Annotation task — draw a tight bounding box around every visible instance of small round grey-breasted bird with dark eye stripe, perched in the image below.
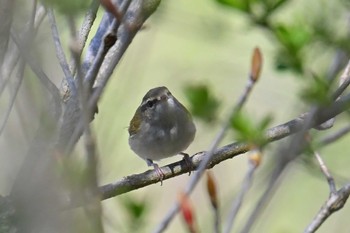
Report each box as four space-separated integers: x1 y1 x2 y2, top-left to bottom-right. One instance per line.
129 87 196 182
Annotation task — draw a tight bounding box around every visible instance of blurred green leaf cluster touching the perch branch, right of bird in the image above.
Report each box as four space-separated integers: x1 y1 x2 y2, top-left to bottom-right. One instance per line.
231 112 272 147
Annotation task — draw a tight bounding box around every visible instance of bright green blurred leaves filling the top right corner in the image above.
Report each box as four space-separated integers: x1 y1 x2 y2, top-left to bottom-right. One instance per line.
216 0 350 74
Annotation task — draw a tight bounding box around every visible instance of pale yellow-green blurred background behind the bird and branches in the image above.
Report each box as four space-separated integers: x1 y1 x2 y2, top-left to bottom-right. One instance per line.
0 0 350 233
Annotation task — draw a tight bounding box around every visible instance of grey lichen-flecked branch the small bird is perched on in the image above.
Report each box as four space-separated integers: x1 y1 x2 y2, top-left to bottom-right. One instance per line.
78 92 350 206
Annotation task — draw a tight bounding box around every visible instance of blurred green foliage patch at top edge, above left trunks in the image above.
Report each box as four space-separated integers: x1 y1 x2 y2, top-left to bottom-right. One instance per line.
41 0 91 16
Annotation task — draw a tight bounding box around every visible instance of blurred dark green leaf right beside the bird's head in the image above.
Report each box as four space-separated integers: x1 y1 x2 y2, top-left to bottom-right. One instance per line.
185 85 220 123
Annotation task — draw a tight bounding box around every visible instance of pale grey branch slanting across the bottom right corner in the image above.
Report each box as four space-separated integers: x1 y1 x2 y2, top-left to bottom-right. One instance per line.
304 183 350 233
